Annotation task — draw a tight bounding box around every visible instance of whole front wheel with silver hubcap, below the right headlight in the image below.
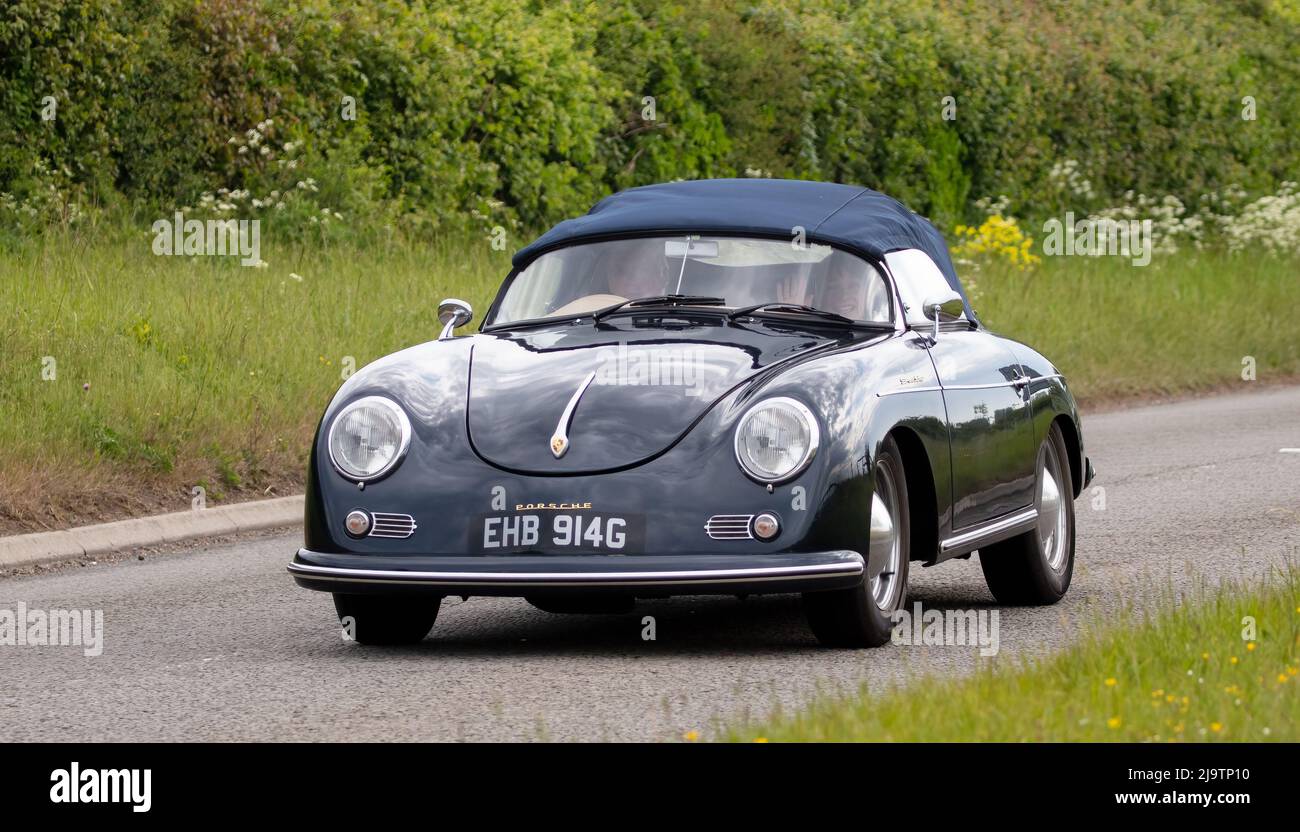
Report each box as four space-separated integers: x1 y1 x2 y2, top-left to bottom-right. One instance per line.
803 437 911 647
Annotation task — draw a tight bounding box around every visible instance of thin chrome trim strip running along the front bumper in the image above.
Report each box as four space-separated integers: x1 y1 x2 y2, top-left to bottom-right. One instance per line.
289 556 866 586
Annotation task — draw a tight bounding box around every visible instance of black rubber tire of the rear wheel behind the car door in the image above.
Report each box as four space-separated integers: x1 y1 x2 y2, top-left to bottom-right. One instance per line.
979 423 1074 606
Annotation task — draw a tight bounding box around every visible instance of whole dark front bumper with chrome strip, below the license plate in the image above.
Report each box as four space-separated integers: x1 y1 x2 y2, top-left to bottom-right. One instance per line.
289 549 866 597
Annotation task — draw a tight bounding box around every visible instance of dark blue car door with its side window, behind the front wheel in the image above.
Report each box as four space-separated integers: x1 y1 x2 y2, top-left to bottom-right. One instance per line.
885 250 1037 532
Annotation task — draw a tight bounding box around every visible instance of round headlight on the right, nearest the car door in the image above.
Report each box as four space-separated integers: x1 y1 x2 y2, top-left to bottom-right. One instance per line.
736 398 818 484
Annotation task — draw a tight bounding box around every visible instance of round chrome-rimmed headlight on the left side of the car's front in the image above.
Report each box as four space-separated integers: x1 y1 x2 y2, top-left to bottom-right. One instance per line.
329 395 411 482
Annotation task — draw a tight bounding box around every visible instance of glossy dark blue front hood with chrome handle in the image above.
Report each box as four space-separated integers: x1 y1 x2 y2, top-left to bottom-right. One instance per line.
467 316 850 475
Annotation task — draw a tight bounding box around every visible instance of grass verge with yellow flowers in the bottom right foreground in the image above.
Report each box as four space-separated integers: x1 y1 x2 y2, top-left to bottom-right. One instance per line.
723 566 1300 742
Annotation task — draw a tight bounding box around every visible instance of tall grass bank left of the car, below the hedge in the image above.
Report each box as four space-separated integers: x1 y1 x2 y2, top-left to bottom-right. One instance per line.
0 222 508 528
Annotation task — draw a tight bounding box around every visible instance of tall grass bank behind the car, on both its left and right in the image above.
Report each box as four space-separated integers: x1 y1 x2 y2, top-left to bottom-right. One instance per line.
0 224 1300 532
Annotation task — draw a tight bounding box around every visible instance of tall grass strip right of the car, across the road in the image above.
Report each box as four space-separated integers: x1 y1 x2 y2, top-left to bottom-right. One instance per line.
974 251 1300 402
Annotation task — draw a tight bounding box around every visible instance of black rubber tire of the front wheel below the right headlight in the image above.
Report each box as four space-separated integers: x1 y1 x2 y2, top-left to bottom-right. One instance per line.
803 437 911 647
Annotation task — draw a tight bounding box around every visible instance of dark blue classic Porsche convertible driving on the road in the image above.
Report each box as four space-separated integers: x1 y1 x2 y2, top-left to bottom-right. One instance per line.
289 179 1092 646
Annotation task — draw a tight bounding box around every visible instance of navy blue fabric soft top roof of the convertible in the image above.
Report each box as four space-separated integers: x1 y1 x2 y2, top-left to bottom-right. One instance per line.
514 179 974 317
